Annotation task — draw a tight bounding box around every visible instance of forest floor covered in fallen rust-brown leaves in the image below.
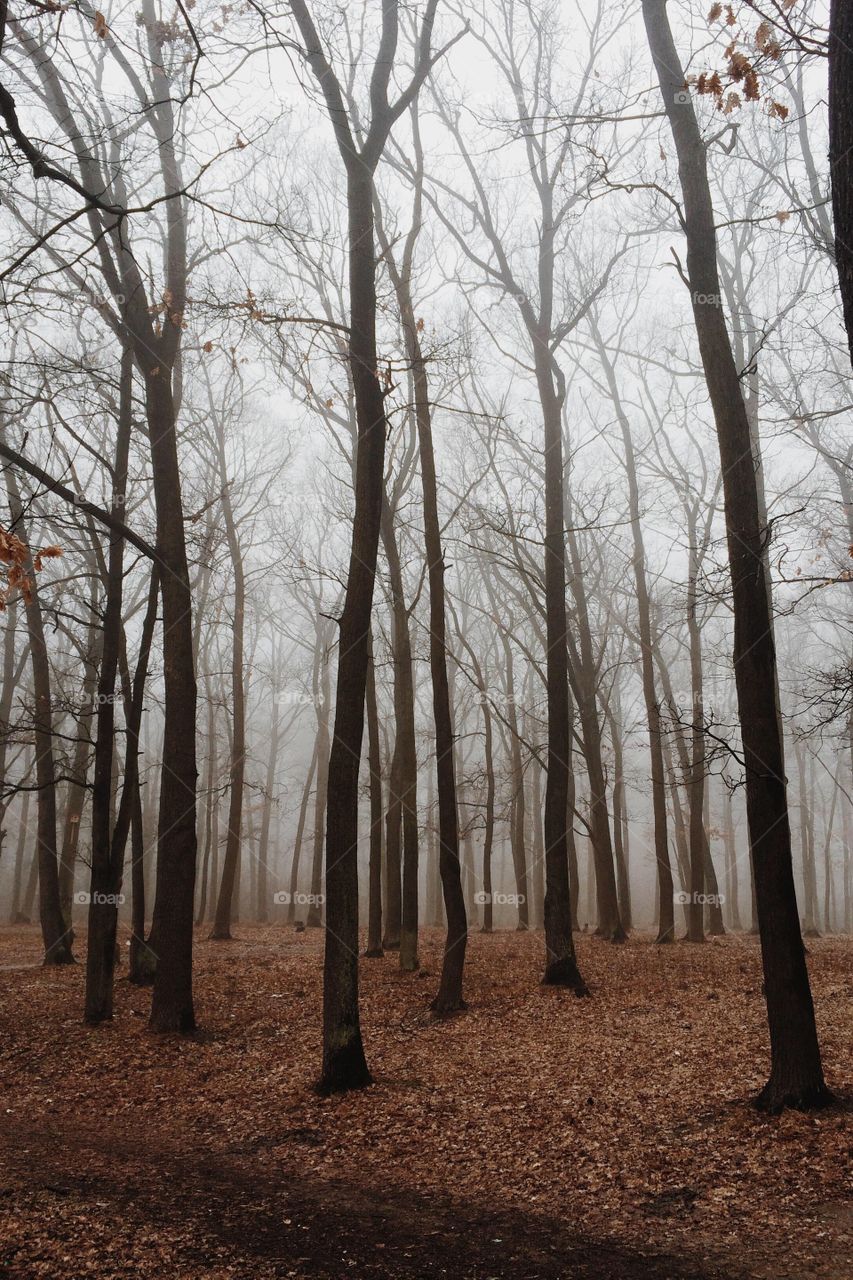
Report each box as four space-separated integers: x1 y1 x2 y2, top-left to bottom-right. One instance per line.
0 925 853 1280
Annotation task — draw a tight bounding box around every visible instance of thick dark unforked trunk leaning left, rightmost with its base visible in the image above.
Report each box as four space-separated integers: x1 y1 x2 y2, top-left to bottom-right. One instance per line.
643 0 831 1111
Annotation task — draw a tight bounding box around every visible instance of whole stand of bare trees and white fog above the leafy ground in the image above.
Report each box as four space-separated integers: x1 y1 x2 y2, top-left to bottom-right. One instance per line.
0 0 853 1110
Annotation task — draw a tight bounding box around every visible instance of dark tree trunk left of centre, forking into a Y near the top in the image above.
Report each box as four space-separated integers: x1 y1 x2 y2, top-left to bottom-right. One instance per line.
289 0 438 1092
